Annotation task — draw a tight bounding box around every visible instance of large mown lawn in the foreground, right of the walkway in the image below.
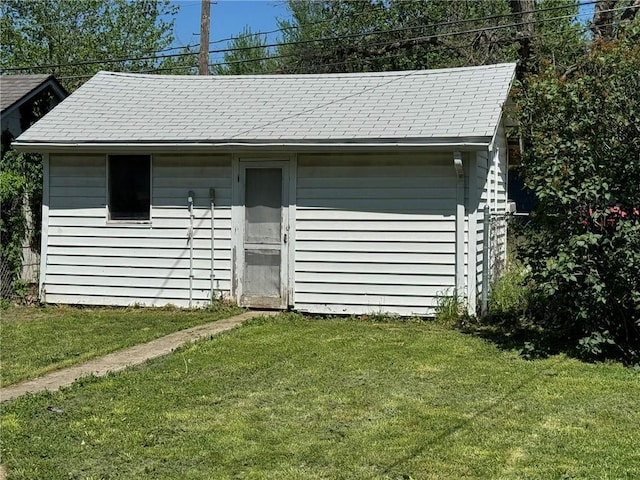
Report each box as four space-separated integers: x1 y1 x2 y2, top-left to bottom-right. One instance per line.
0 315 640 479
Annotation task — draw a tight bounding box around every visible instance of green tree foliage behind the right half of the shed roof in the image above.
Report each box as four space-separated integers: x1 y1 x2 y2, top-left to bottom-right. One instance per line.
278 0 585 73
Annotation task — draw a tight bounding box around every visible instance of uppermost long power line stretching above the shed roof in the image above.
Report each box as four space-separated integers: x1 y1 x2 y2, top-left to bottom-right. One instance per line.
4 0 600 71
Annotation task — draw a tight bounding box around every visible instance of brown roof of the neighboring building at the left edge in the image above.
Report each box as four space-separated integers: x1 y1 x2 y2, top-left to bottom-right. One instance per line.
0 75 68 113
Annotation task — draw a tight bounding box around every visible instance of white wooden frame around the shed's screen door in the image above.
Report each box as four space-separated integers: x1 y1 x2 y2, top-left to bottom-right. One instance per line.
231 154 295 310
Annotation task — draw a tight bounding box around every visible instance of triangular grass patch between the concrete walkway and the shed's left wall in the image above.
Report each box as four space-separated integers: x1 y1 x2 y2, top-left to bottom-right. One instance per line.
0 306 240 386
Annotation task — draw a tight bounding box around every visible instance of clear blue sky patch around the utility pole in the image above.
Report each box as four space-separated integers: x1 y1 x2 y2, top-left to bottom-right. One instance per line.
171 0 289 61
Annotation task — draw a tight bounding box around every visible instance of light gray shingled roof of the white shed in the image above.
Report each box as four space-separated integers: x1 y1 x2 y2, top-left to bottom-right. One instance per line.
13 64 515 145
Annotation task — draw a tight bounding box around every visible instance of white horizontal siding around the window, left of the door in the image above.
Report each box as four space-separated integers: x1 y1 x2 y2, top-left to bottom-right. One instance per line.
45 155 231 306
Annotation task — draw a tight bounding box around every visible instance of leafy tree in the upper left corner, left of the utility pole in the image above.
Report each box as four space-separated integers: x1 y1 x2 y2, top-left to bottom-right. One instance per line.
0 0 185 90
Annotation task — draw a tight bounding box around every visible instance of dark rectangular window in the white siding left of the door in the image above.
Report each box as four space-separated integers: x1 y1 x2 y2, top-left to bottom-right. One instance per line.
109 155 151 221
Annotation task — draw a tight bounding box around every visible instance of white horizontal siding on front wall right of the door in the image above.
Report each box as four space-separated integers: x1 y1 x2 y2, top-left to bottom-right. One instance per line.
294 154 456 315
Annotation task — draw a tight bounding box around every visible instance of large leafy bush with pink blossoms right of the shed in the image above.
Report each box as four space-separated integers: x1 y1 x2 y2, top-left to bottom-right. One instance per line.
515 19 640 362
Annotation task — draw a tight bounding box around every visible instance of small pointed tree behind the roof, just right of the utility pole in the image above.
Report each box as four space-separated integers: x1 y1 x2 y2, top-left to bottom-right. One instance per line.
213 27 278 75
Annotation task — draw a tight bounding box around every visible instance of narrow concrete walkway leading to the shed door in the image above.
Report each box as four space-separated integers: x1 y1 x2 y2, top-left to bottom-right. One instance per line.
0 311 280 404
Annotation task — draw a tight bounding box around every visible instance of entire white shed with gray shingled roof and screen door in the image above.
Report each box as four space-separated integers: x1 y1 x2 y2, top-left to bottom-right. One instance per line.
15 64 515 316
